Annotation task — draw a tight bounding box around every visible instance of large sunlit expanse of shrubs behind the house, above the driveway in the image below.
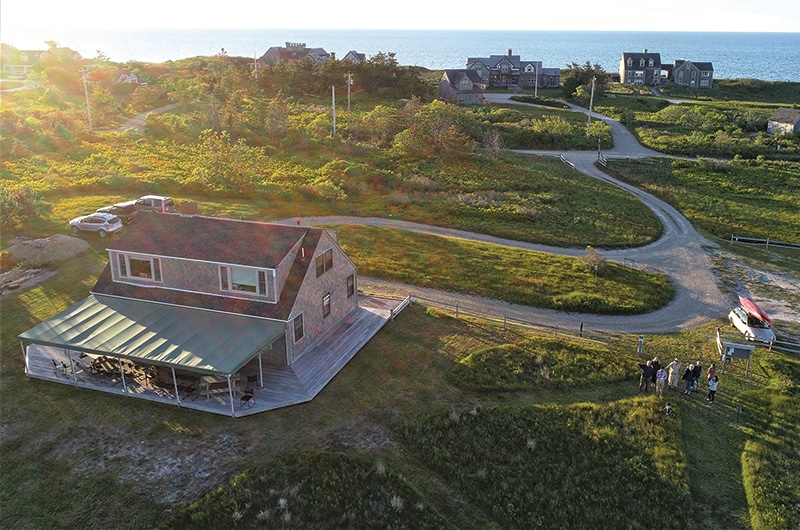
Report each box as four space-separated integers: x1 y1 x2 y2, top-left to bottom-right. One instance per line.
0 54 661 248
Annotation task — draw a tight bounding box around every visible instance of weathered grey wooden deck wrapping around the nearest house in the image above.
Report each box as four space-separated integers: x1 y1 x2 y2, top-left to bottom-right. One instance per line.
21 295 400 417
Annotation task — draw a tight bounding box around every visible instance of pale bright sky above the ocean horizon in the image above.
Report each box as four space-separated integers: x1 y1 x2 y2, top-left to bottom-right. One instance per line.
0 0 800 32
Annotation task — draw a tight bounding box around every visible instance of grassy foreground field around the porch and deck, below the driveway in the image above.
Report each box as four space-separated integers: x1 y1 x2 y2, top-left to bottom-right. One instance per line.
0 254 800 528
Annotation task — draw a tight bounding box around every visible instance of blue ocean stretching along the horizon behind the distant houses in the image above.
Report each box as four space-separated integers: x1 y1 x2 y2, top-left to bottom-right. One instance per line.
2 28 800 82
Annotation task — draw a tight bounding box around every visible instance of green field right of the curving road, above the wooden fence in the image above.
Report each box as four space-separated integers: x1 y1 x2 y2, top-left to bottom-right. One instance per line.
608 159 800 242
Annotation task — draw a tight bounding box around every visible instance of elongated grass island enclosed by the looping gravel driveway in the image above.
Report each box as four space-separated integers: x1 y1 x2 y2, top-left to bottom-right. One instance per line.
339 226 675 314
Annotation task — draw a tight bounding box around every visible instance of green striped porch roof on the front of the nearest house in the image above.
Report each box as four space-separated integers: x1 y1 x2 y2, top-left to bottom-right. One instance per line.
19 295 285 374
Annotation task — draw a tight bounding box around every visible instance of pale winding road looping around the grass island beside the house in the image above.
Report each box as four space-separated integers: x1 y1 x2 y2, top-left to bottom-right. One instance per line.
282 94 733 333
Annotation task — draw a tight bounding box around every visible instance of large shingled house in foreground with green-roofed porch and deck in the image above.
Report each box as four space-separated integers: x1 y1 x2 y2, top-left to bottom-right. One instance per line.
19 212 388 416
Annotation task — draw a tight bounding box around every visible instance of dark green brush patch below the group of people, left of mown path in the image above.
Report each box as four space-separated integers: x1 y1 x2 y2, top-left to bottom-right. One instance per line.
402 399 692 528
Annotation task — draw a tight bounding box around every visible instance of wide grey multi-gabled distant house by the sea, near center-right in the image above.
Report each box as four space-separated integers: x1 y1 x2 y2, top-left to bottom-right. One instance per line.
467 49 561 88
